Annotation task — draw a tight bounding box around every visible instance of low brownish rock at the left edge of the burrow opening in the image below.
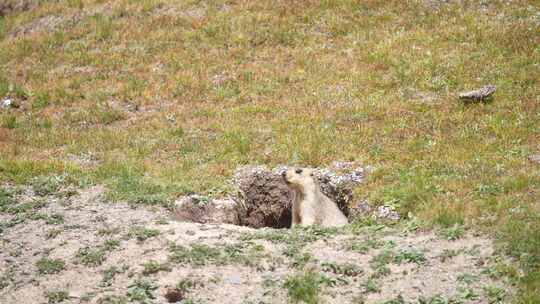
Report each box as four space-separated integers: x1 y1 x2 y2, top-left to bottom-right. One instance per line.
173 195 239 225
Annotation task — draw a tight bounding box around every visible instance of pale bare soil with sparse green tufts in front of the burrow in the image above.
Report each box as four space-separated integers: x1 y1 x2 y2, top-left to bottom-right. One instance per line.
0 187 509 304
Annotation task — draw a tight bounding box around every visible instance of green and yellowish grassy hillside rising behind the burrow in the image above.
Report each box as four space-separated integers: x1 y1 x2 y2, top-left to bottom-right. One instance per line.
0 0 540 303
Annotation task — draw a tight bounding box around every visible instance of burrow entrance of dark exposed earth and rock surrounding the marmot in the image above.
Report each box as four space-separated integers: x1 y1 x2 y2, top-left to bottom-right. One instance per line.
173 163 364 228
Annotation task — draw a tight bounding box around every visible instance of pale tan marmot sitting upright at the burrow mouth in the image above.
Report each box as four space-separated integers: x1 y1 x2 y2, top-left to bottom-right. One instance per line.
282 168 348 228
